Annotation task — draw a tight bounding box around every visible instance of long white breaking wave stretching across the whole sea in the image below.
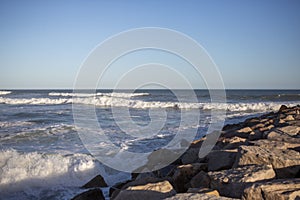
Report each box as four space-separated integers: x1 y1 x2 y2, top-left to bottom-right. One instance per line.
0 96 299 112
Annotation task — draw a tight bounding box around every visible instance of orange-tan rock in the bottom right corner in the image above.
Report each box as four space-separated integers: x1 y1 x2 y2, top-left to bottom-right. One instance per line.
242 179 300 200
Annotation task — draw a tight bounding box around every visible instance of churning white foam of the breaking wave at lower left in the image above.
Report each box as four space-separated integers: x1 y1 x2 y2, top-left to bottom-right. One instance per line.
0 150 128 192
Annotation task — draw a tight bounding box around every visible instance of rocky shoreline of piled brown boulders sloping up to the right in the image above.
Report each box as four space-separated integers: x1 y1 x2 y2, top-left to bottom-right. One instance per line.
73 105 300 200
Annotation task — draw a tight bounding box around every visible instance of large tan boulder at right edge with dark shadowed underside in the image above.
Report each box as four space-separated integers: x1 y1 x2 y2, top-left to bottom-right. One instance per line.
233 146 300 178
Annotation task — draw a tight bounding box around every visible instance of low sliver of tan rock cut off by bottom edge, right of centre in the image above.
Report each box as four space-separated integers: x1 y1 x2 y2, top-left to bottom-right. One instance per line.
165 193 238 200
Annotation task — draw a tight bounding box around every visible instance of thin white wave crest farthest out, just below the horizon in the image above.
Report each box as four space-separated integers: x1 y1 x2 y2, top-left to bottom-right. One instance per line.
48 92 150 98
